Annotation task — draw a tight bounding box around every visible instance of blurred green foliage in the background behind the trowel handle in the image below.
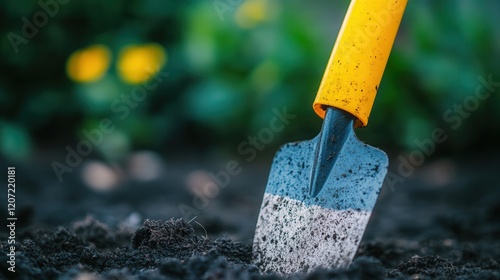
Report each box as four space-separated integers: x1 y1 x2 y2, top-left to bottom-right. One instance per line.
0 0 500 159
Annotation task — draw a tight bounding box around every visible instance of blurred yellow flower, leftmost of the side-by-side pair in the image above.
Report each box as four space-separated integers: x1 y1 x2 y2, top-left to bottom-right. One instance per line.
66 45 111 83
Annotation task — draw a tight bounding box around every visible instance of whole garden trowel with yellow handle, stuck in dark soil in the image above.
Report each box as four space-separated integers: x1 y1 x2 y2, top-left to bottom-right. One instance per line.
253 0 407 275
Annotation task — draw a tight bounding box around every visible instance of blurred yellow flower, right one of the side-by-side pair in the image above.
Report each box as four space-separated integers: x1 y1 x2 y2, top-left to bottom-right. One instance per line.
118 43 167 84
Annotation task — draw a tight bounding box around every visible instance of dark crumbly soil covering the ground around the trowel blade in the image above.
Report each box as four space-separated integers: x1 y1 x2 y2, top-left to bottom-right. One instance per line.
0 154 500 279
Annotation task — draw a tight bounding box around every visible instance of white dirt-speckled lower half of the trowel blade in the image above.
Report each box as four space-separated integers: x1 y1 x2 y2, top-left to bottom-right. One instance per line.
253 193 371 275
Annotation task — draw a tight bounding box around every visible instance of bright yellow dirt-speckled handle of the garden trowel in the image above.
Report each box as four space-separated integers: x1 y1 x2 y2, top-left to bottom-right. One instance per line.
313 0 408 126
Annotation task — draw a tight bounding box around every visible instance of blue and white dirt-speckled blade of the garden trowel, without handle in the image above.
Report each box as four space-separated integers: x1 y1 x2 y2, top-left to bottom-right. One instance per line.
253 128 389 275
